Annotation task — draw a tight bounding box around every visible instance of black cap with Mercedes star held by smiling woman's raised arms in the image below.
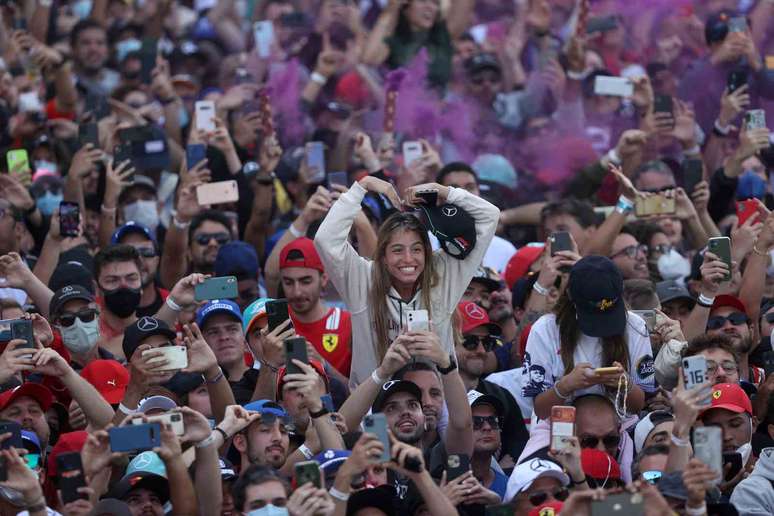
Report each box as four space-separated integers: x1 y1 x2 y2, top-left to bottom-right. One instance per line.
420 204 476 260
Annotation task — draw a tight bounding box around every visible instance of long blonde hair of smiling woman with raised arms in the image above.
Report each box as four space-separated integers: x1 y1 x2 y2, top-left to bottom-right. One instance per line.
368 213 438 362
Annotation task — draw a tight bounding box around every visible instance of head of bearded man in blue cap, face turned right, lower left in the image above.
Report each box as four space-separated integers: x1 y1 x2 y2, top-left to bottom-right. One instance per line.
233 400 292 470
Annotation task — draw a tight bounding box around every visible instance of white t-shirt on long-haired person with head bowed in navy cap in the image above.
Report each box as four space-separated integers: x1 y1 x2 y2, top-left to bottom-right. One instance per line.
519 312 654 418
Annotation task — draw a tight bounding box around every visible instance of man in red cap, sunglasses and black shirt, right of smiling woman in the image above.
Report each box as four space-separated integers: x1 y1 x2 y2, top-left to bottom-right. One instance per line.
454 301 529 460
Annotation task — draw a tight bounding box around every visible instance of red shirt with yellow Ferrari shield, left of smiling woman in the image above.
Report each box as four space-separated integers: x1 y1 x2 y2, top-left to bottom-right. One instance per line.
288 308 352 378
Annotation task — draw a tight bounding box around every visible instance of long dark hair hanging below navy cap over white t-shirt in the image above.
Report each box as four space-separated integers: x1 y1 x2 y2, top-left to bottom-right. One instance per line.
554 289 629 374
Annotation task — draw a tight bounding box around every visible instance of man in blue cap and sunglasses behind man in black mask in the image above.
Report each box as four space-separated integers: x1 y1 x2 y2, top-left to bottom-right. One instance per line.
110 221 169 317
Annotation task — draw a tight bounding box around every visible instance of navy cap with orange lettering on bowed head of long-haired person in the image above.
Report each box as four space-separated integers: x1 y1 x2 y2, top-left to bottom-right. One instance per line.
569 256 626 338
